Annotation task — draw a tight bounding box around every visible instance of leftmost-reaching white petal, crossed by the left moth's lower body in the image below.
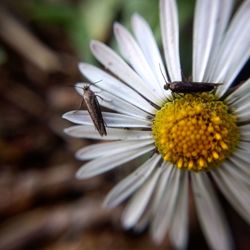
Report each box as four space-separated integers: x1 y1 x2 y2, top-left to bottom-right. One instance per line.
63 110 151 128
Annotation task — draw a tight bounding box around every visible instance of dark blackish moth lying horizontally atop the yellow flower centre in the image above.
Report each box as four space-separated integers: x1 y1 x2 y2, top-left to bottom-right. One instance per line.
164 81 221 94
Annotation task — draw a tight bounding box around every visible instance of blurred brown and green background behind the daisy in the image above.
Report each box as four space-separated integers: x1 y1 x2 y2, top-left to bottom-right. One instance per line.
0 0 250 250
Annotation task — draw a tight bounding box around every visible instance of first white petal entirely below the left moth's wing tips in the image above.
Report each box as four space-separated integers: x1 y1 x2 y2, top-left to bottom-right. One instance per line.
76 139 154 160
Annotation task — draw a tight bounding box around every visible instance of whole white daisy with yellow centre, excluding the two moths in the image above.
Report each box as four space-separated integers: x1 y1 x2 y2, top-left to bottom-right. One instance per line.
64 0 250 250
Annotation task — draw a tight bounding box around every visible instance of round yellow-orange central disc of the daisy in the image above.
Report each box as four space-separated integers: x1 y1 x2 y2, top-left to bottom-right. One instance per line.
152 93 239 171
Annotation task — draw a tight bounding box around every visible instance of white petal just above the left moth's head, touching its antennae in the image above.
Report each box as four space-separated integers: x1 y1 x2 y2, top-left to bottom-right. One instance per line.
79 63 155 114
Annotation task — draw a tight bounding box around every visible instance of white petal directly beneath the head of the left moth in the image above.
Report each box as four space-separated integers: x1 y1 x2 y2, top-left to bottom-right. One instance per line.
76 83 152 117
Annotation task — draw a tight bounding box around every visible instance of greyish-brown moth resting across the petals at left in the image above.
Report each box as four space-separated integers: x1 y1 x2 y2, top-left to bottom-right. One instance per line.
77 84 107 136
